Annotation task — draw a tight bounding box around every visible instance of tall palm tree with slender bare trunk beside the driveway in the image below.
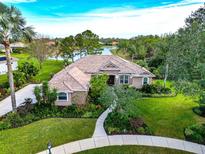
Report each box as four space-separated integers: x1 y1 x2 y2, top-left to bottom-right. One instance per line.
0 3 35 111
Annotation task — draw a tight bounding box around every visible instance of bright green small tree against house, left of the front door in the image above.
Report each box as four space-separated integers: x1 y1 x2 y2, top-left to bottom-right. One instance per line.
89 74 108 103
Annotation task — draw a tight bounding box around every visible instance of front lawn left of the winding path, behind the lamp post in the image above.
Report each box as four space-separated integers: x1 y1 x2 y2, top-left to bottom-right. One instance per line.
0 118 96 154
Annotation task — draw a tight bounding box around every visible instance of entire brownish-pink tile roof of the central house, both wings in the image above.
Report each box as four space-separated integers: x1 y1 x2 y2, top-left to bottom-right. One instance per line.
49 55 154 92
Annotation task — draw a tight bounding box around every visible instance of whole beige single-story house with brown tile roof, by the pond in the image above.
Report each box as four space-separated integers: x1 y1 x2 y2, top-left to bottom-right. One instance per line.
49 55 155 106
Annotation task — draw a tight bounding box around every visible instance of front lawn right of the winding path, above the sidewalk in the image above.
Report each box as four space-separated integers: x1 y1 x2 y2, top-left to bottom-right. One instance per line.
136 95 205 139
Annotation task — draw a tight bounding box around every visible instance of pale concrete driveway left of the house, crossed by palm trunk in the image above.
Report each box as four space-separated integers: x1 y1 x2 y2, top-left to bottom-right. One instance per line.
0 84 39 117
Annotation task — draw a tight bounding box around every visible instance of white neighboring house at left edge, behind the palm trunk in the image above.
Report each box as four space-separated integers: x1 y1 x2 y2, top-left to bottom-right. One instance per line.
0 57 18 75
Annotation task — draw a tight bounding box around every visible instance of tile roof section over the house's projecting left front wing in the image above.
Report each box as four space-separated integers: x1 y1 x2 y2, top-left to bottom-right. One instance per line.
49 67 90 92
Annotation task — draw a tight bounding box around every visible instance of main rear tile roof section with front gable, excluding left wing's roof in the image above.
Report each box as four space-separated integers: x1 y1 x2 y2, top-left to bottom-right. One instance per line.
67 55 155 77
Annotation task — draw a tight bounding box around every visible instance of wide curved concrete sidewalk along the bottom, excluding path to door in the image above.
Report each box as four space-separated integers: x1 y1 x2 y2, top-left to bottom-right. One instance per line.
39 135 205 154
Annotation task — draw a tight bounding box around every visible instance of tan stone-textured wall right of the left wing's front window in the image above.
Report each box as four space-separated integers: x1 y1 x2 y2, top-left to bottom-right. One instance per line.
71 91 88 105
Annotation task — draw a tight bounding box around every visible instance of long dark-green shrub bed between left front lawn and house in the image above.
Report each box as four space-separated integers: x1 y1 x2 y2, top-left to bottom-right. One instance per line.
0 99 104 130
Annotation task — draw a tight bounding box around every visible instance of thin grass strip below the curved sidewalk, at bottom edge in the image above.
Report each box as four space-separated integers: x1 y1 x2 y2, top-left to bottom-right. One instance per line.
78 146 189 154
